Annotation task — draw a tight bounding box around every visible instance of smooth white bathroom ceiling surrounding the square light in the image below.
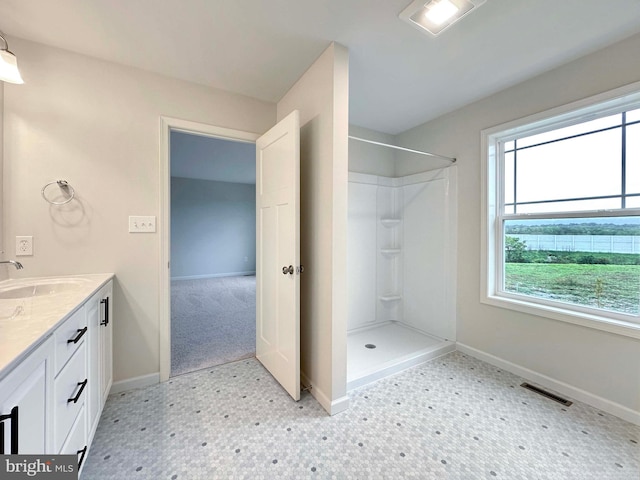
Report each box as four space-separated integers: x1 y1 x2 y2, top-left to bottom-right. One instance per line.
0 0 640 134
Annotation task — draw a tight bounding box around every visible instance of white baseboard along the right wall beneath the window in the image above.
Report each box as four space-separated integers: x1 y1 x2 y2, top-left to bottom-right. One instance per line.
456 342 640 425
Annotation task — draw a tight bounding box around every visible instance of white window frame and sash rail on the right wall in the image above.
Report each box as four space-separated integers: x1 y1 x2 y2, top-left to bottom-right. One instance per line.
480 82 640 338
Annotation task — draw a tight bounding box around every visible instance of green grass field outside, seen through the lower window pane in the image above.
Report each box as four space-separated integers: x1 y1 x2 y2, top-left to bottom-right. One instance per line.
505 263 640 315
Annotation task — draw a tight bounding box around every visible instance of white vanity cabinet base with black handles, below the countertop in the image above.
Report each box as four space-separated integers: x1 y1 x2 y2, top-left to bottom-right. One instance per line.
0 280 113 468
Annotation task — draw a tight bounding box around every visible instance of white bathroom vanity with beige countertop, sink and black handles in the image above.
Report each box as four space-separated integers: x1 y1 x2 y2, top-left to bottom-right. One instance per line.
0 274 113 469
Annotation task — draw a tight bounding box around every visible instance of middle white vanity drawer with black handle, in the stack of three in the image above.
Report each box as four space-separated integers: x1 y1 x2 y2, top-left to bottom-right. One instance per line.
53 342 88 451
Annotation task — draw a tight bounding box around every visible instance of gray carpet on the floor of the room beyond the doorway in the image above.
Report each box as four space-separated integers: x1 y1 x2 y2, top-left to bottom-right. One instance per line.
171 276 256 376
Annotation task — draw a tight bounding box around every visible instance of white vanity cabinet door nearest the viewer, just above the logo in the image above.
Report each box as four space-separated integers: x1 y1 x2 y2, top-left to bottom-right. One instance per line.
0 336 53 455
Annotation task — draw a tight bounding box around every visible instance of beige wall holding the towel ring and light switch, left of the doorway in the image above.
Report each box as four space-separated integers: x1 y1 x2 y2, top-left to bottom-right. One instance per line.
3 38 276 388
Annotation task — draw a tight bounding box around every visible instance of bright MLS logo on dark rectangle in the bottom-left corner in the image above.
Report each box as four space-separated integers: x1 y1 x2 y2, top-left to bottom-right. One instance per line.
0 455 78 480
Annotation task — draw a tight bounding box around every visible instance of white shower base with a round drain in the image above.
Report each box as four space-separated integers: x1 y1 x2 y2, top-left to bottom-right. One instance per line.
347 322 455 390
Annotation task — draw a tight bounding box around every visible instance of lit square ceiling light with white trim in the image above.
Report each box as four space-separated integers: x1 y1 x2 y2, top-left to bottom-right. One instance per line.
399 0 486 36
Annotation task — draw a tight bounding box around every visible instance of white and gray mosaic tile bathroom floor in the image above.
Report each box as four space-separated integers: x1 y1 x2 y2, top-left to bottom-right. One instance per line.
82 352 640 480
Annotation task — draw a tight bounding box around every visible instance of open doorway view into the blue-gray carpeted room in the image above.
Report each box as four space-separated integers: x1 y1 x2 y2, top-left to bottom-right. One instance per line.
169 130 256 376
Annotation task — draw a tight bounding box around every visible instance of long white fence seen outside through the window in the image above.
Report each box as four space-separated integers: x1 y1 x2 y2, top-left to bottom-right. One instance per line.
507 233 640 254
